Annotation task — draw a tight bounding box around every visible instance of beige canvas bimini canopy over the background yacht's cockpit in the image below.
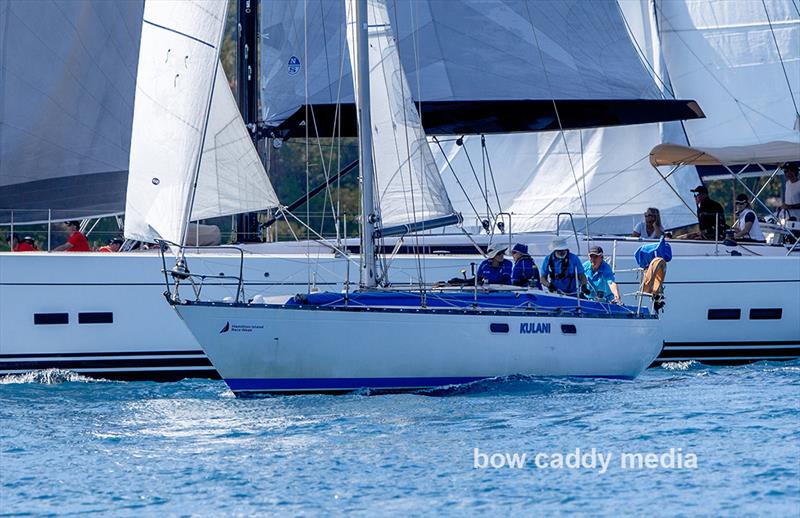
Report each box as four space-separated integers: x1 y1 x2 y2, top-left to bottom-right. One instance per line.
650 140 800 166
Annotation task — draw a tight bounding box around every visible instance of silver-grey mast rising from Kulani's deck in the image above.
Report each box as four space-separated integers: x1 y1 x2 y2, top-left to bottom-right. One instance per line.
355 0 377 288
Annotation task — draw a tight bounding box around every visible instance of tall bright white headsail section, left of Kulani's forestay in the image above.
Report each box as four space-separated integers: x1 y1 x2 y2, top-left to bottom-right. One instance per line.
125 0 227 243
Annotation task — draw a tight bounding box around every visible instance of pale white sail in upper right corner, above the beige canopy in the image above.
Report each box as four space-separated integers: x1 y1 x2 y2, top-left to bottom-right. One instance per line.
660 0 800 147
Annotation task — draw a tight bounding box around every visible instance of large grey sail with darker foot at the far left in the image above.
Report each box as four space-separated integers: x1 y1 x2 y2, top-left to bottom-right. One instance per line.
0 0 143 223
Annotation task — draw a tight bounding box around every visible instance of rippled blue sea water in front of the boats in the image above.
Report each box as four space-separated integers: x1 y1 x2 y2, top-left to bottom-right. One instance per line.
0 362 800 516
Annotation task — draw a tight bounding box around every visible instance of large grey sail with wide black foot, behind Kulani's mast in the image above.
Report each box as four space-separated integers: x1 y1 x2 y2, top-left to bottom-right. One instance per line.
262 0 700 137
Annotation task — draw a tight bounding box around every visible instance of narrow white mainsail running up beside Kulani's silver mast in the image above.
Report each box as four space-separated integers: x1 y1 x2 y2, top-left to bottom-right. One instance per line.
348 0 453 227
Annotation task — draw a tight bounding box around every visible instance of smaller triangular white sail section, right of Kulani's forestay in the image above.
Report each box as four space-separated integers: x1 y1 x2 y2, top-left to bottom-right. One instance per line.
191 63 278 221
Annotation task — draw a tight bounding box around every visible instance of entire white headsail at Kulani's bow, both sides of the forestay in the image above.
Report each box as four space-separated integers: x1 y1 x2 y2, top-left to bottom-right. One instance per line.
125 0 277 243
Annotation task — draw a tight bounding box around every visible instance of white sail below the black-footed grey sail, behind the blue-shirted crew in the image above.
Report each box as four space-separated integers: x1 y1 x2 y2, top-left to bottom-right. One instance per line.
436 128 698 234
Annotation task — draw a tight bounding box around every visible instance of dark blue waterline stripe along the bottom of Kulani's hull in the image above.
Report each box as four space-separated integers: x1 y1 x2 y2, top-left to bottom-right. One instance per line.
225 376 632 392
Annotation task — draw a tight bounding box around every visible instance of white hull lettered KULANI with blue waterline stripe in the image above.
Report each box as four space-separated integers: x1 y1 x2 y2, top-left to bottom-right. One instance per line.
175 303 663 395
